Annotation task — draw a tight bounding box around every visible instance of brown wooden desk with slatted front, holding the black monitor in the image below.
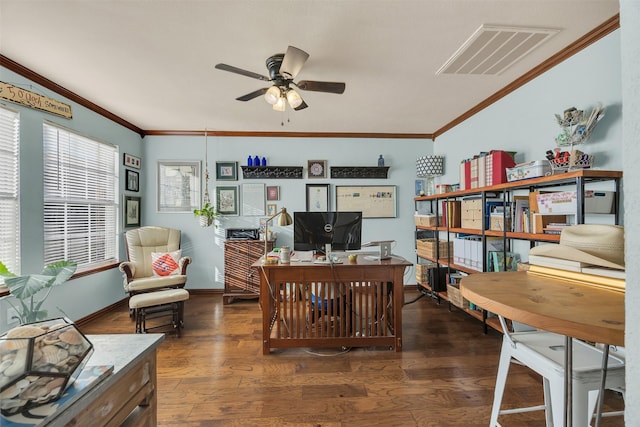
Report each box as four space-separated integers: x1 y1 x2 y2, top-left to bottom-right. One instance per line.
252 254 412 354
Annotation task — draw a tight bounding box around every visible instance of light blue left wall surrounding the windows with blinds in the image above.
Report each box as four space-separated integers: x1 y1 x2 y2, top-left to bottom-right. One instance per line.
0 67 142 331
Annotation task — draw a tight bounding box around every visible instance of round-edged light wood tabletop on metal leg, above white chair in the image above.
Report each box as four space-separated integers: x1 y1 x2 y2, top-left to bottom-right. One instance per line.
460 271 625 425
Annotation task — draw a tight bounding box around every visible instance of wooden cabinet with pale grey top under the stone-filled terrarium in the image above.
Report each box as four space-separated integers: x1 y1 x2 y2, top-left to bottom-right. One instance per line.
4 334 164 427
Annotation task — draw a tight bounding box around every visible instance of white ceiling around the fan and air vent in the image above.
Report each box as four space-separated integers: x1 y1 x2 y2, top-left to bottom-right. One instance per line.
0 0 619 136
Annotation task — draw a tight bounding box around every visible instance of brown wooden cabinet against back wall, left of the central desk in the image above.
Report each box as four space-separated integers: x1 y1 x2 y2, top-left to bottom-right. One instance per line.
222 240 273 304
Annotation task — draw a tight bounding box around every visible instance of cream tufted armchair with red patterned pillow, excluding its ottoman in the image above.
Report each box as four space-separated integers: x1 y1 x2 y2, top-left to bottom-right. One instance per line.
119 226 191 296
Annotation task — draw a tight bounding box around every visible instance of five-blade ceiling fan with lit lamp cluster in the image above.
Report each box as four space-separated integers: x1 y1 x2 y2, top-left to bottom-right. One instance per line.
216 46 346 111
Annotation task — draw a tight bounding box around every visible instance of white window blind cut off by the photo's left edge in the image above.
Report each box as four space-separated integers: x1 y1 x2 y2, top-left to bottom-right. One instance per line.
0 107 20 276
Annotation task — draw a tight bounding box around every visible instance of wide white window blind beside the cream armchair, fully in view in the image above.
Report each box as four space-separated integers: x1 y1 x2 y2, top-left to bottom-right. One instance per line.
43 123 118 268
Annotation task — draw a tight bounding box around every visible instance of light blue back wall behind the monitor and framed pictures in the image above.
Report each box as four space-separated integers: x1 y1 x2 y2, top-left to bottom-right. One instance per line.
142 136 432 289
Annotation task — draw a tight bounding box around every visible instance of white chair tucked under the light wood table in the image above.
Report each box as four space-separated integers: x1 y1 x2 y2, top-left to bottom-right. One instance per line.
489 316 624 427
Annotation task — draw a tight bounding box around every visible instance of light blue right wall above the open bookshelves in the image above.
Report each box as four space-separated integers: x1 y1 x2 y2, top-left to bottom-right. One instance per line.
434 31 622 182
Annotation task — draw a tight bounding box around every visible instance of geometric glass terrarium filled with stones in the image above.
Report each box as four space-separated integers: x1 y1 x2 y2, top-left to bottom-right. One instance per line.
0 318 93 416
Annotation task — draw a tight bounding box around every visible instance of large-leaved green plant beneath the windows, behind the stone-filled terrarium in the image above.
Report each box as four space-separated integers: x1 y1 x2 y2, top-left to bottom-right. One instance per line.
0 261 78 324
